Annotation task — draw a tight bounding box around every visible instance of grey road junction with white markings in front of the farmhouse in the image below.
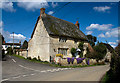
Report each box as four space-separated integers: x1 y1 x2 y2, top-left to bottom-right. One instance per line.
2 56 109 81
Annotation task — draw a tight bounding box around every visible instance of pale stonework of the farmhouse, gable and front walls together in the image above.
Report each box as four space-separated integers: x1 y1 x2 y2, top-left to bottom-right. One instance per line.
27 19 88 62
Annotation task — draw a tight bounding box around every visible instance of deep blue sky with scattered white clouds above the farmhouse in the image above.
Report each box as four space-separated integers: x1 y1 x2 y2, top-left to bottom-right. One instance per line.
0 1 118 47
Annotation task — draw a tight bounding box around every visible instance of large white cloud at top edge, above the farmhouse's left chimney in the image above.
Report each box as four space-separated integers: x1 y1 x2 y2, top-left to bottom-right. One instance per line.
17 0 49 11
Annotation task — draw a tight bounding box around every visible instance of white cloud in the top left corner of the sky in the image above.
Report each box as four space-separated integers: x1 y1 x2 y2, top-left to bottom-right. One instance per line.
0 2 16 12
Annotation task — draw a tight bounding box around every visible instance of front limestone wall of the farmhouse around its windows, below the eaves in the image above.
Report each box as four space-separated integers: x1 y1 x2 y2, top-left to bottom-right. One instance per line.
50 36 80 58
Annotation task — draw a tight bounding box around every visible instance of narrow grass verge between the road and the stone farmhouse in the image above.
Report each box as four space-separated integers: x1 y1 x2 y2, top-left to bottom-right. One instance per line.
12 54 104 68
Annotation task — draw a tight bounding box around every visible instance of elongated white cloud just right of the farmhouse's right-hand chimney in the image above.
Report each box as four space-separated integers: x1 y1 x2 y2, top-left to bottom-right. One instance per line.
86 24 113 31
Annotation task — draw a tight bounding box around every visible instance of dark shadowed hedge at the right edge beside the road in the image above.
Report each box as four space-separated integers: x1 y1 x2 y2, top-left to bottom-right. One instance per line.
102 44 120 83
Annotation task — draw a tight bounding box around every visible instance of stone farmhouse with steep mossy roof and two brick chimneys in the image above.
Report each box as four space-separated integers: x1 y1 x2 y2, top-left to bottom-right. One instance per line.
27 8 88 62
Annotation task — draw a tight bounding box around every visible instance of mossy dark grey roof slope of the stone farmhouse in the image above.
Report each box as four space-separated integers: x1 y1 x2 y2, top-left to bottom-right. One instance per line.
31 14 87 40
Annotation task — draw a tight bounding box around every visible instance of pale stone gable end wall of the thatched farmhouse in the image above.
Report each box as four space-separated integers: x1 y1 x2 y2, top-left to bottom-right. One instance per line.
28 19 50 61
